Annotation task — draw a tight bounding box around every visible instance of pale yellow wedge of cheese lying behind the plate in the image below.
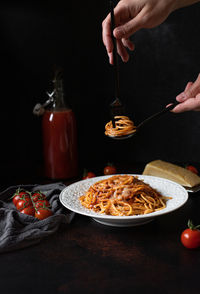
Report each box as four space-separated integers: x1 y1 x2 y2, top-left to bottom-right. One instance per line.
143 160 200 187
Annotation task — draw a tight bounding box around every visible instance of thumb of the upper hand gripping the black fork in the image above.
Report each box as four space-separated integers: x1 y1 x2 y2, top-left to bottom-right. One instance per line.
113 14 143 39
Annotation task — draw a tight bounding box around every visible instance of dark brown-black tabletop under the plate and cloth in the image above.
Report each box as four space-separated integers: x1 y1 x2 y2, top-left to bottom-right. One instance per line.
0 165 200 294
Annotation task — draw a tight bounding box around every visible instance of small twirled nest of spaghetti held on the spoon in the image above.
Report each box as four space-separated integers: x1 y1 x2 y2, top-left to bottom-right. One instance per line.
105 116 136 137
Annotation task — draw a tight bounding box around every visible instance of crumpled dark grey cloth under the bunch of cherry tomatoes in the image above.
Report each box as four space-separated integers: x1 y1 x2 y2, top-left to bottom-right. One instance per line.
0 183 74 253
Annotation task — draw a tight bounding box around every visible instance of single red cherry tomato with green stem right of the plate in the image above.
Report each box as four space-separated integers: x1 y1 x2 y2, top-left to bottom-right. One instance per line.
181 220 200 249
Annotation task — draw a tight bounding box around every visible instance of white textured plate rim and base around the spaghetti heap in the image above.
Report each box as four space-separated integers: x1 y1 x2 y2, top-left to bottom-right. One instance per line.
60 174 188 227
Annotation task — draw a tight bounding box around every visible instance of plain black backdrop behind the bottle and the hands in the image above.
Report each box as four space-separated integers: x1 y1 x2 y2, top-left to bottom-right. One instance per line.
0 0 200 177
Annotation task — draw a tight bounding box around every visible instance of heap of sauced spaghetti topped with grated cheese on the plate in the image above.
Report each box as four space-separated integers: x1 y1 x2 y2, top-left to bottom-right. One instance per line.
80 175 171 216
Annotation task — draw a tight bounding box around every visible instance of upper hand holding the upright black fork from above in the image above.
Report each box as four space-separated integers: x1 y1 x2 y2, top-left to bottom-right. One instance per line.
102 0 177 64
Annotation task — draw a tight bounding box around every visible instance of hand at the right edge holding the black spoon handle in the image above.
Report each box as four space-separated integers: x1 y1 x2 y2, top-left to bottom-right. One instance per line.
172 74 200 113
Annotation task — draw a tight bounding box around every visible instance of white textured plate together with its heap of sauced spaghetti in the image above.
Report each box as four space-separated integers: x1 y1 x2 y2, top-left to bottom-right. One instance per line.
60 174 188 227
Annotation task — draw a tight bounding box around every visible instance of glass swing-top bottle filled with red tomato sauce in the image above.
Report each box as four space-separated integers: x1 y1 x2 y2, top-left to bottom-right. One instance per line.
42 72 78 179
